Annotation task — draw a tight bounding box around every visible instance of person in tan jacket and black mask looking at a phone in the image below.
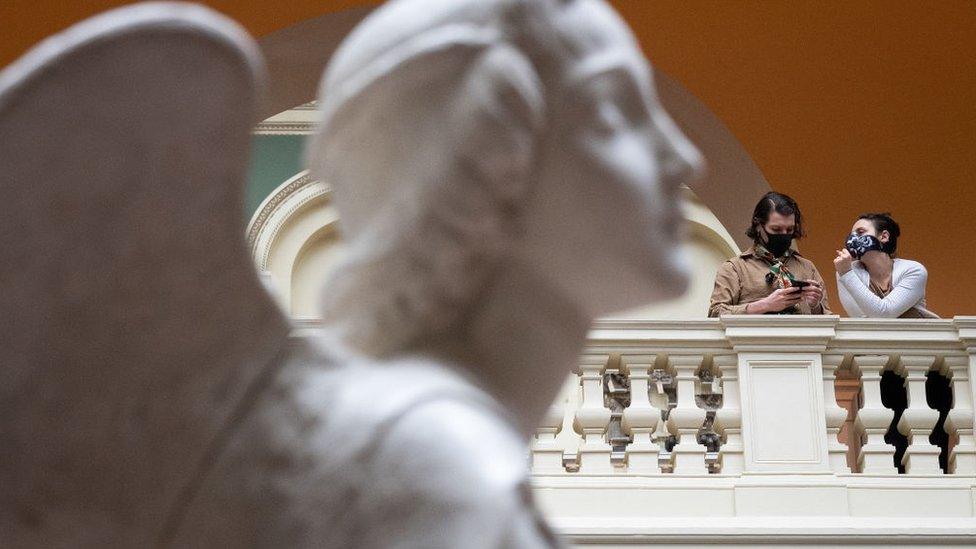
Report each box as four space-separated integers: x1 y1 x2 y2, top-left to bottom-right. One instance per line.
708 192 832 317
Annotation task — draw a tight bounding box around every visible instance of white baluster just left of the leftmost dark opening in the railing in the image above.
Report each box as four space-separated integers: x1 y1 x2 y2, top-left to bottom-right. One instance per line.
576 355 612 473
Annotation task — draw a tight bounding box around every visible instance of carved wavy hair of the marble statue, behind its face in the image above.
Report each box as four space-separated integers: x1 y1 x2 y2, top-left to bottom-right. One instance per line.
309 0 568 355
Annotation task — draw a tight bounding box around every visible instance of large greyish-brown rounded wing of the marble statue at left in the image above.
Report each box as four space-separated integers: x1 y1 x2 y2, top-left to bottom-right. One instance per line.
0 3 288 531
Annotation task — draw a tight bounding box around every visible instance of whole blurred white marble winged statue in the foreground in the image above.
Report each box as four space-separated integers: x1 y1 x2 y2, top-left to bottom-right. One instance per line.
0 0 700 548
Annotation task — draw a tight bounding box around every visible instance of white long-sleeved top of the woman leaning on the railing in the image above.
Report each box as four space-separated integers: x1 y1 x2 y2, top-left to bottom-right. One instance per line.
837 260 928 318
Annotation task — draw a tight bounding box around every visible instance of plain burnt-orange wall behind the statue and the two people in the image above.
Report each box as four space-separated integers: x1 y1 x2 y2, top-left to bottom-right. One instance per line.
7 0 976 316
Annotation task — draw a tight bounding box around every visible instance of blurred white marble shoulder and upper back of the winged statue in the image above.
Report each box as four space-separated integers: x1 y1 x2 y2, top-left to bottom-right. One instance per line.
174 341 534 547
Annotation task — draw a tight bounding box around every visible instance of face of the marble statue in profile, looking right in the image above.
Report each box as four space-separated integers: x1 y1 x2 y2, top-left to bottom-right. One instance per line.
533 0 701 314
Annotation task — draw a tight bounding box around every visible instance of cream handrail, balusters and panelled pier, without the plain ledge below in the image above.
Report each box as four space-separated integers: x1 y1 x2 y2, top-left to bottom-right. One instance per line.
533 317 976 476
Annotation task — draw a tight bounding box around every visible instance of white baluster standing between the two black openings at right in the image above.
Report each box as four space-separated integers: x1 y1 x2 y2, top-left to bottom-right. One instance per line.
898 355 942 475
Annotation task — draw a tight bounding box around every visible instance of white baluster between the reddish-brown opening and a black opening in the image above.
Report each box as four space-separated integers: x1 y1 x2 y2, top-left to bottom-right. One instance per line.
853 355 898 475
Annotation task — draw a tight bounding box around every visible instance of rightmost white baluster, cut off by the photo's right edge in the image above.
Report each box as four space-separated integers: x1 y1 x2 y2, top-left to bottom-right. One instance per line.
944 356 976 477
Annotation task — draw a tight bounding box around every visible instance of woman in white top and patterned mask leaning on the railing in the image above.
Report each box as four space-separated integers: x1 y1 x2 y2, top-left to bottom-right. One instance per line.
834 213 938 318
